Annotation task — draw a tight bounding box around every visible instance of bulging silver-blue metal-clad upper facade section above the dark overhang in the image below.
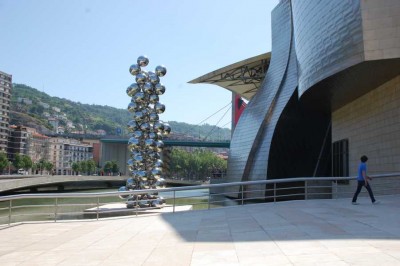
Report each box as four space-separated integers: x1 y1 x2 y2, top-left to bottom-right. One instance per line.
292 0 364 96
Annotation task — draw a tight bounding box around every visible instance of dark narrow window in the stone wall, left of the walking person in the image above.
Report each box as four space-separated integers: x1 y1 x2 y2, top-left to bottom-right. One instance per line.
332 139 349 184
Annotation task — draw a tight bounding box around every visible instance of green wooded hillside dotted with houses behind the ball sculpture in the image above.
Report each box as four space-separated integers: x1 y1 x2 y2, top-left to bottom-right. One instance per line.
10 84 230 140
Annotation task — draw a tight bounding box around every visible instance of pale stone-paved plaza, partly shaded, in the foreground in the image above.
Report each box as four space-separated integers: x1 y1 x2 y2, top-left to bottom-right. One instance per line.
0 196 400 266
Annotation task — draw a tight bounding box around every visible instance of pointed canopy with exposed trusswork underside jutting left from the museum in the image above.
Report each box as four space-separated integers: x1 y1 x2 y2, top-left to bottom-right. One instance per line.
189 53 271 100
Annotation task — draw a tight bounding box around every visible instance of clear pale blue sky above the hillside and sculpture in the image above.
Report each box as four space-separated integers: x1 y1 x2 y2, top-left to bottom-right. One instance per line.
0 0 279 128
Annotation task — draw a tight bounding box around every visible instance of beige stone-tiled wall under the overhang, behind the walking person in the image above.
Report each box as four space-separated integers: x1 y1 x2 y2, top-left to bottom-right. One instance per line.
332 76 400 176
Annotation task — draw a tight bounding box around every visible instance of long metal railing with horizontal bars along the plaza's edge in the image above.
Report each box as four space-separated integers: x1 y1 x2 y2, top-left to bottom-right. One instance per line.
0 173 400 228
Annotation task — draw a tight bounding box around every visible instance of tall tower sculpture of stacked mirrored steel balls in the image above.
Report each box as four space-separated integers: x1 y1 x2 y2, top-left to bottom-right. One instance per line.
119 56 171 208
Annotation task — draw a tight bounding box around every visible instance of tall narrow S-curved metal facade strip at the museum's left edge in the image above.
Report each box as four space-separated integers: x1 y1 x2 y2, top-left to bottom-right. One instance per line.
227 0 292 195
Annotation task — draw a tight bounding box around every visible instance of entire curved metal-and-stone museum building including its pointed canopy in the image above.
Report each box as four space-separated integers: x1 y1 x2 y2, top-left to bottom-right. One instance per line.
191 0 400 196
